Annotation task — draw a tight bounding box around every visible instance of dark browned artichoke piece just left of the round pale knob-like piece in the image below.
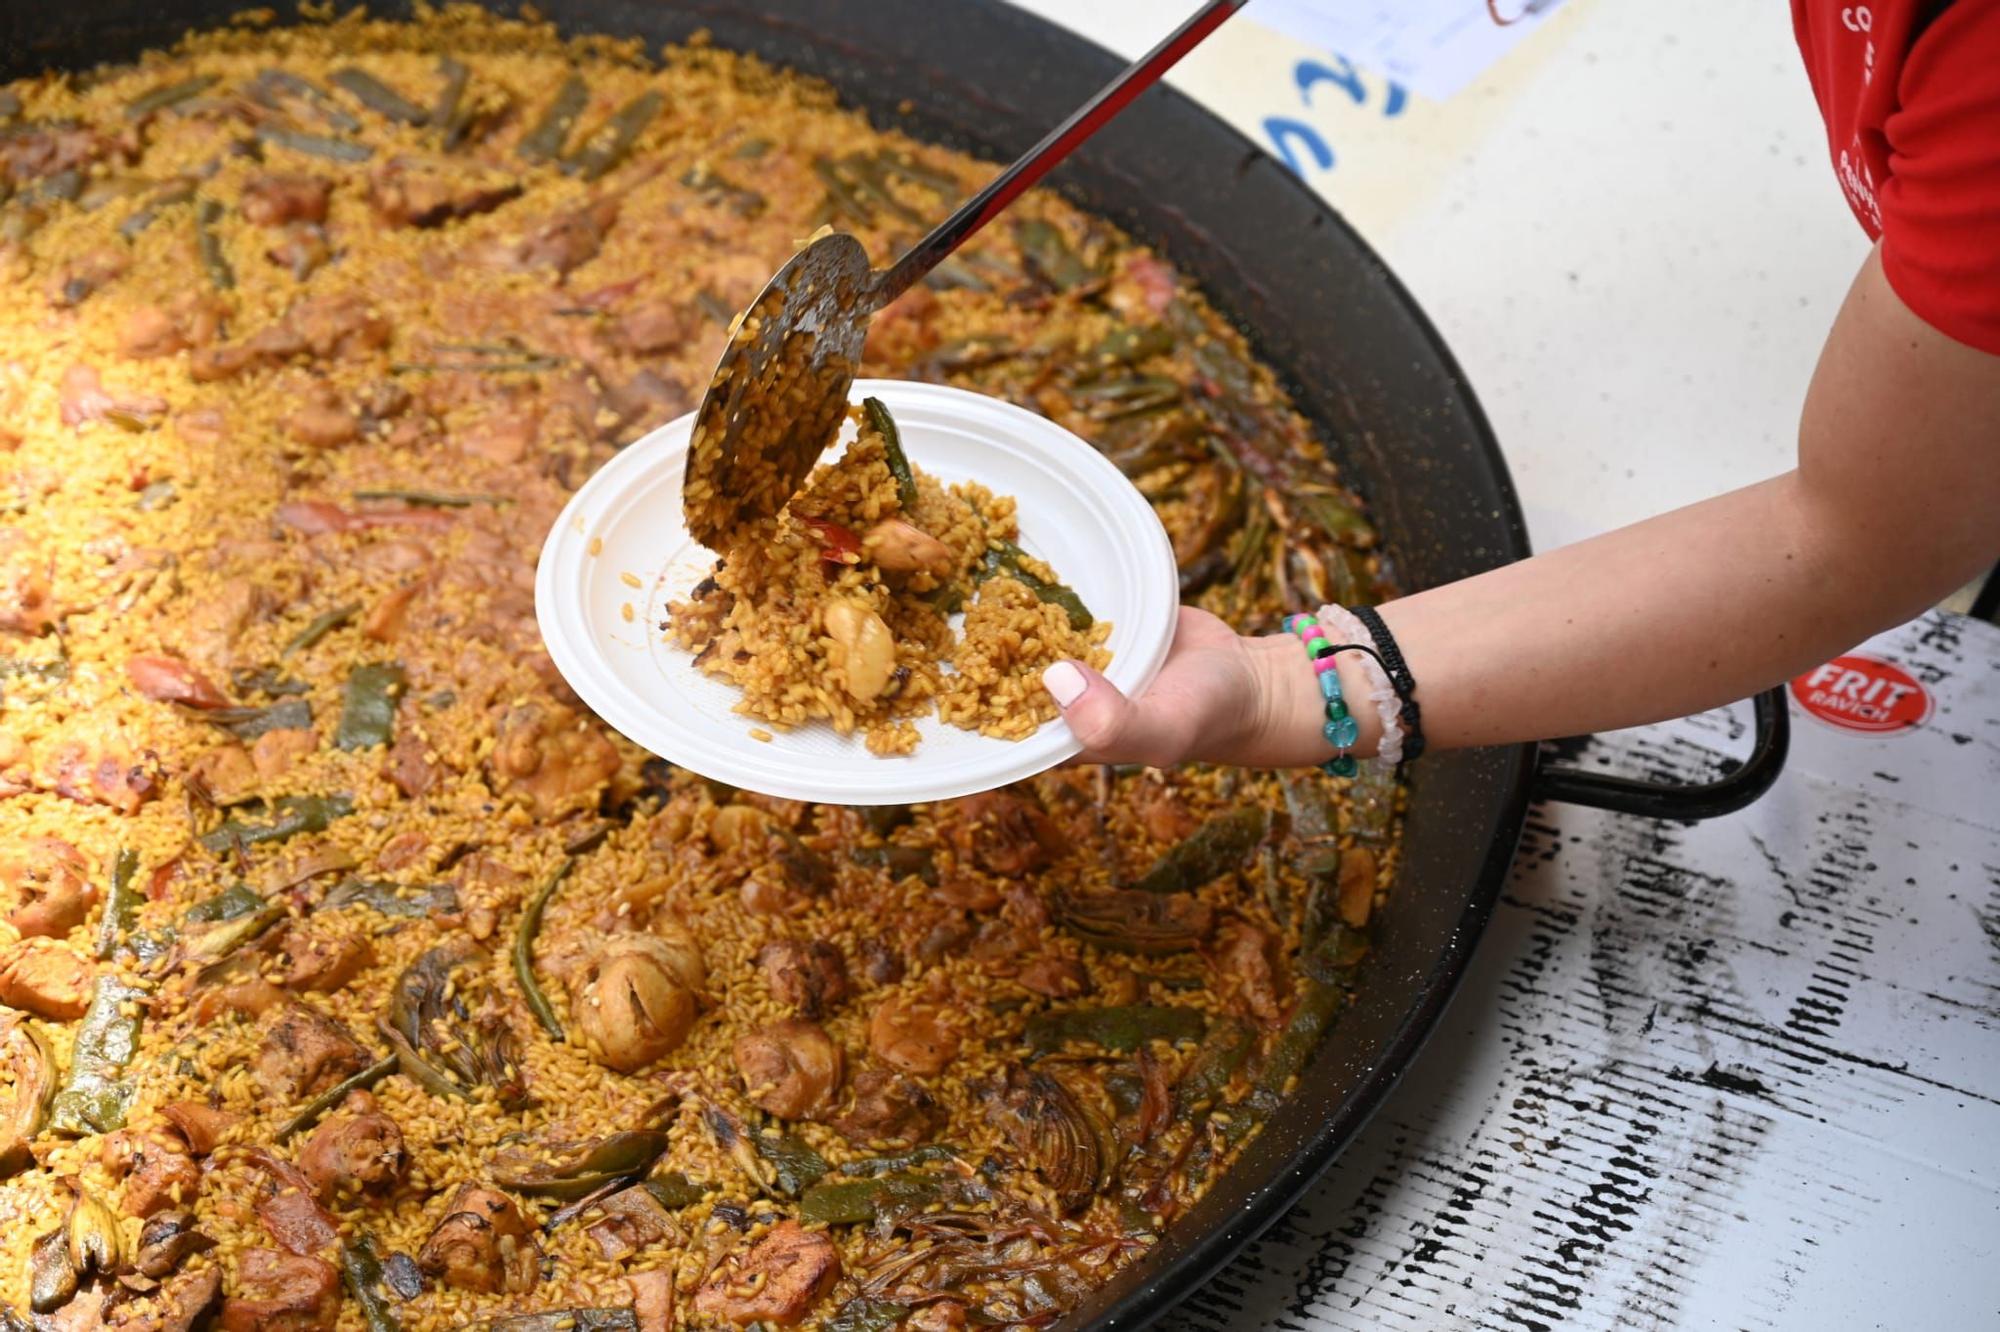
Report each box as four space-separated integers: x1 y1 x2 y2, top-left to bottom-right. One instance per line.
382 938 530 1110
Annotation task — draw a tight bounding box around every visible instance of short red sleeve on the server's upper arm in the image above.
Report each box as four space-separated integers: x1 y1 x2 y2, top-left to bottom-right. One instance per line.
1882 0 2000 354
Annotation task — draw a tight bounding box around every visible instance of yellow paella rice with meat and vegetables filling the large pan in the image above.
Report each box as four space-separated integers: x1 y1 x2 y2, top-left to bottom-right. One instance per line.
0 10 1398 1332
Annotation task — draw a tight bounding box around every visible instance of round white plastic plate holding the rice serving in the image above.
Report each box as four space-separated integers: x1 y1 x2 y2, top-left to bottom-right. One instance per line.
534 380 1180 804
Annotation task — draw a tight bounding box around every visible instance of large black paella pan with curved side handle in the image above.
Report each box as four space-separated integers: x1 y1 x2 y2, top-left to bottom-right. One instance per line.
0 0 1782 1326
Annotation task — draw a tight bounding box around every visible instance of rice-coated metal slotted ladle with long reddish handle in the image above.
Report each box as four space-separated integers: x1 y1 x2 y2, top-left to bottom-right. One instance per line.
682 0 1248 550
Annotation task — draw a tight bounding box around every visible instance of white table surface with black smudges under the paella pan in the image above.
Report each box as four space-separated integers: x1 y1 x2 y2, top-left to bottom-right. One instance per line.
988 0 2000 1332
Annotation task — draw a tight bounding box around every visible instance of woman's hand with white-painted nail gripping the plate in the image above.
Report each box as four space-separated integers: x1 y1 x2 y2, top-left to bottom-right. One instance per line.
1042 606 1374 768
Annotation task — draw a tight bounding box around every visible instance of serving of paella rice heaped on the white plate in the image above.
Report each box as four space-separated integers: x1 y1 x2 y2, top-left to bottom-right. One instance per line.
666 400 1112 754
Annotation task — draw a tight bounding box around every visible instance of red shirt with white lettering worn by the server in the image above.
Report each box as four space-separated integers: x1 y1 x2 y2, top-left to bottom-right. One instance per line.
1792 0 2000 354
